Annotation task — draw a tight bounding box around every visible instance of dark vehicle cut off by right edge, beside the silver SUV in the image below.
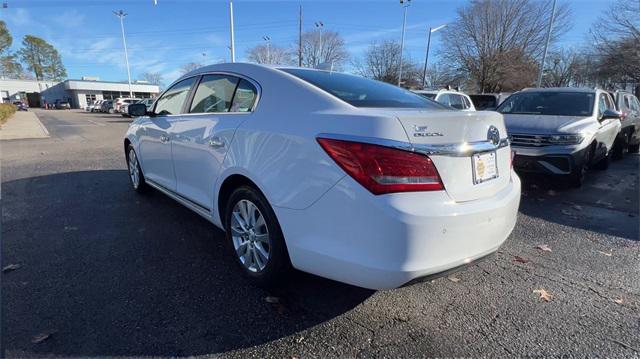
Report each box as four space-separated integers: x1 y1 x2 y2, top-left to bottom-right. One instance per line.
610 91 640 159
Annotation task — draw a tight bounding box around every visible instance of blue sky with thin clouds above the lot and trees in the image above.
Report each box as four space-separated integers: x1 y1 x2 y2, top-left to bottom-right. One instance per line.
0 0 611 83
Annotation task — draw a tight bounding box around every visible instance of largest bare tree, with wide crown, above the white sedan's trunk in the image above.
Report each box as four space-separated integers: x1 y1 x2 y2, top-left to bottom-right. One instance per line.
442 0 570 92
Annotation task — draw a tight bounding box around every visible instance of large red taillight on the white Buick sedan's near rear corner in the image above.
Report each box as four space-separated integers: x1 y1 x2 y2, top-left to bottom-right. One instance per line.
318 138 444 194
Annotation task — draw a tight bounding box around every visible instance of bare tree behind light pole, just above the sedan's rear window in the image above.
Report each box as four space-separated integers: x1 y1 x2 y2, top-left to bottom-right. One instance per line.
353 40 421 87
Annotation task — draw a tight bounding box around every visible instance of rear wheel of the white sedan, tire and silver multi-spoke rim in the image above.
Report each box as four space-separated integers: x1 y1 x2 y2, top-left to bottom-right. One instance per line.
224 186 292 287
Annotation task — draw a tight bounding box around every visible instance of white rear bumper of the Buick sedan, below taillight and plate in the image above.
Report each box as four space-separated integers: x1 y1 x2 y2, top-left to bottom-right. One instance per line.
274 172 520 289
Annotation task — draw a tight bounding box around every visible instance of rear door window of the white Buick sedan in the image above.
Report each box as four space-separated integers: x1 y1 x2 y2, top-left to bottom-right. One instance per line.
189 75 239 113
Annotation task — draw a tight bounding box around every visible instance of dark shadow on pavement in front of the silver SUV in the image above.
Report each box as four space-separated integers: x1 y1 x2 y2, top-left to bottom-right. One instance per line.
520 155 640 241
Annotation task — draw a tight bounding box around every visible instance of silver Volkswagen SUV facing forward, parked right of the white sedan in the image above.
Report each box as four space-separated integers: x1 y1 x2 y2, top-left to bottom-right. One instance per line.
498 88 621 187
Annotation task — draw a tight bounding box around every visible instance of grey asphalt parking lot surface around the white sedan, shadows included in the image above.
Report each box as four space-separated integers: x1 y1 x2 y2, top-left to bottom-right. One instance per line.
0 111 640 358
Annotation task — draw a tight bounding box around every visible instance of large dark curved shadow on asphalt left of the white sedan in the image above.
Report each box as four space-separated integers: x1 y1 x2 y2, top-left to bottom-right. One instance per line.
2 170 374 357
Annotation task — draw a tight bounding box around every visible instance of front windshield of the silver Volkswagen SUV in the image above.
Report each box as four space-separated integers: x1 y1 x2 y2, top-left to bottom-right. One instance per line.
498 92 595 116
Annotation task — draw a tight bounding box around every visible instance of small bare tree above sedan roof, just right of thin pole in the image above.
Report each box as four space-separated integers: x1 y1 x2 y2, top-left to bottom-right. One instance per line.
302 30 349 69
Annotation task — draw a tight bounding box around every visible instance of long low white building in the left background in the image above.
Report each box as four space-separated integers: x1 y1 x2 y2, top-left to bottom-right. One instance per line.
0 77 160 108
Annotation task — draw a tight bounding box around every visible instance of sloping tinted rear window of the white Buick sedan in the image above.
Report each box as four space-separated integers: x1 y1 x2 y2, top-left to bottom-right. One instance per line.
282 69 448 110
